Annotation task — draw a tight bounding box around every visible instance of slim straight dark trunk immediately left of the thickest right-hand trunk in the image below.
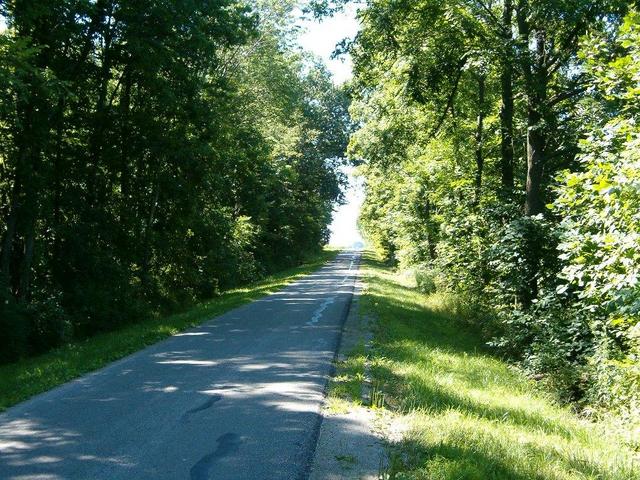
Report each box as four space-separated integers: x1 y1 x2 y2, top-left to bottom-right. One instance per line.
500 0 514 197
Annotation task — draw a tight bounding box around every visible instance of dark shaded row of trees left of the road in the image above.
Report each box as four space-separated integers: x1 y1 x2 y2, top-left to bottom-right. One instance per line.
0 0 349 361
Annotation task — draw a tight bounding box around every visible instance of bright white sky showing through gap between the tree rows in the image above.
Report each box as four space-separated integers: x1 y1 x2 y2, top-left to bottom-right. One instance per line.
298 7 364 247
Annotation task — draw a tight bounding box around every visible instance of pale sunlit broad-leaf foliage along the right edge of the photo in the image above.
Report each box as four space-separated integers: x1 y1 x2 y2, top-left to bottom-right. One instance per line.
554 12 640 424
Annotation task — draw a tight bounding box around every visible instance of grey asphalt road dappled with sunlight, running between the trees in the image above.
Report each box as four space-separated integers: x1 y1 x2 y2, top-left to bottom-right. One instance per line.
0 252 358 480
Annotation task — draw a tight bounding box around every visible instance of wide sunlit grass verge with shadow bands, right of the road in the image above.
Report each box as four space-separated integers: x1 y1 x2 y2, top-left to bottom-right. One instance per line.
361 254 640 480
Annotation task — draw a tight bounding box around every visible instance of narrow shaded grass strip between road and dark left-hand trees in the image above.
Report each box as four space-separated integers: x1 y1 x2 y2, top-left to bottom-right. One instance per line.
0 249 338 411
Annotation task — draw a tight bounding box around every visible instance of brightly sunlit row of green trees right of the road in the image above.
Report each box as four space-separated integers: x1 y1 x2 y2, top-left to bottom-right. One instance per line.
328 0 640 444
